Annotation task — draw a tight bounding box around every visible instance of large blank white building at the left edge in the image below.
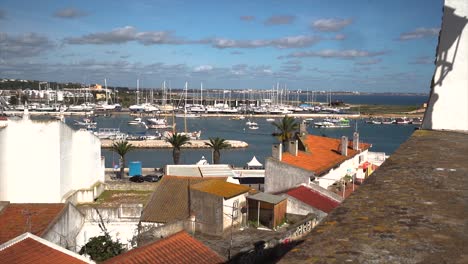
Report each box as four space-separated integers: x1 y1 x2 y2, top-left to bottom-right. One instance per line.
0 113 104 203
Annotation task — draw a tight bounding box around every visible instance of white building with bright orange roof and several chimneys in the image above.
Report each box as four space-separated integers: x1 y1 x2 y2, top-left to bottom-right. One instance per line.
265 133 371 193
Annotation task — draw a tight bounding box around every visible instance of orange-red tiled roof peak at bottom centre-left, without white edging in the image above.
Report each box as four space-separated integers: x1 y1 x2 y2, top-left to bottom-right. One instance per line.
105 231 224 264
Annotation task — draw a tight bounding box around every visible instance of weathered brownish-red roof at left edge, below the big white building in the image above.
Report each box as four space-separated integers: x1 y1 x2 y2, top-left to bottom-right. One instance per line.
0 203 66 244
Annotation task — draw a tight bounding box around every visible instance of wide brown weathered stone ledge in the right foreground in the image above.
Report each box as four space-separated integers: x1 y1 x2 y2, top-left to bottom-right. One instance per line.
281 130 468 263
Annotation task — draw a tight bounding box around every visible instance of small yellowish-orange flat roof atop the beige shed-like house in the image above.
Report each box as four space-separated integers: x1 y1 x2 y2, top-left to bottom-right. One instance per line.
190 180 250 199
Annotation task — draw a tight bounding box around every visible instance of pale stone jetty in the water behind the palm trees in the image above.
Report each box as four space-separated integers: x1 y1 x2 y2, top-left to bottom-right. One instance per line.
101 139 249 149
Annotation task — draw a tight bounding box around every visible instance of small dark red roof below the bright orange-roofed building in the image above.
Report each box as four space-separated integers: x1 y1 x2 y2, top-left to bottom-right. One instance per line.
286 185 340 214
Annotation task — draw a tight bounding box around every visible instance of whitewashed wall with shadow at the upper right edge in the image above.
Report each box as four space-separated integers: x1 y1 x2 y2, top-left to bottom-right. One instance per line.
422 0 468 131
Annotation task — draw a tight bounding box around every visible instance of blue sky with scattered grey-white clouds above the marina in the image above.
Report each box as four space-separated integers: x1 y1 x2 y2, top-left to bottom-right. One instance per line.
0 0 443 93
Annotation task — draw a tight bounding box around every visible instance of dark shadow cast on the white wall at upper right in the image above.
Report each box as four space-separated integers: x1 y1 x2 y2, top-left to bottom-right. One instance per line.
423 3 468 129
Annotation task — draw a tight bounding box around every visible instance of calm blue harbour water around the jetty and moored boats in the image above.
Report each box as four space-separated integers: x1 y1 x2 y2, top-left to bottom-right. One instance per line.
67 115 415 167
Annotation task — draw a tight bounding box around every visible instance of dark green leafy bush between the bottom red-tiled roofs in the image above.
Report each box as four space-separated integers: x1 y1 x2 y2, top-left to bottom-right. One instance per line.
78 233 125 262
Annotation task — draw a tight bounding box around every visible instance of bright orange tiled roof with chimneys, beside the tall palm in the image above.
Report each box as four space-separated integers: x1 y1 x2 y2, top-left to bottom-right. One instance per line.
281 135 371 175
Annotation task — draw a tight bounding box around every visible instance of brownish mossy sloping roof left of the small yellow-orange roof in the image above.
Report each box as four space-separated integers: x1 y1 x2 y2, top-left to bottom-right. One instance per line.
141 175 226 223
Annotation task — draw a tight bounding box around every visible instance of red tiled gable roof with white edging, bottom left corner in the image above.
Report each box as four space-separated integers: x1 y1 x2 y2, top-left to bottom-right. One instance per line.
0 234 90 264
